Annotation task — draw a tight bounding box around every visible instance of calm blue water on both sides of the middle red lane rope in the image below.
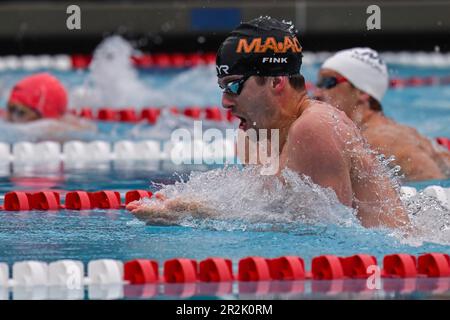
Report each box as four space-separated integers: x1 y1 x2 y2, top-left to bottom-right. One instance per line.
0 164 450 263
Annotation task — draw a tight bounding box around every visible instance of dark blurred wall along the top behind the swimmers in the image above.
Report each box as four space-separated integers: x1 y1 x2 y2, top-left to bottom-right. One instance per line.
0 0 450 54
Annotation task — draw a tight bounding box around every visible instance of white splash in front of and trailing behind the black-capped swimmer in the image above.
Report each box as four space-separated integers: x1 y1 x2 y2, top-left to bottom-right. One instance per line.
134 167 450 246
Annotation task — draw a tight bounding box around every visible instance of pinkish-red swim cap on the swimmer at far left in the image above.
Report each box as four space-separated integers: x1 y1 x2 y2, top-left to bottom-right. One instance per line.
8 73 67 118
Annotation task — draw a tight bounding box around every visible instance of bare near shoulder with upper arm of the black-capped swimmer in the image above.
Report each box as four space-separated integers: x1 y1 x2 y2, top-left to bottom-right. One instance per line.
280 101 352 206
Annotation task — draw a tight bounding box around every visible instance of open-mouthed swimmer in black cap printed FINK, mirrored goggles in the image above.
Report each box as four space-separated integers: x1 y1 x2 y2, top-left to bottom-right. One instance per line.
128 17 409 228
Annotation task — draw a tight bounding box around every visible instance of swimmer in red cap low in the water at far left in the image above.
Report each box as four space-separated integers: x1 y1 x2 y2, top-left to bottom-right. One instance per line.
6 73 96 141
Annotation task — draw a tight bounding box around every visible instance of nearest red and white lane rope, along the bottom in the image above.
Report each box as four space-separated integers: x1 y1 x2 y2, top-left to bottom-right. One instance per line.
0 253 450 289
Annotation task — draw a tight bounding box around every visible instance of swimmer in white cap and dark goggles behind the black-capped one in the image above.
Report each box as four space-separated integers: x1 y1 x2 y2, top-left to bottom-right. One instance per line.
314 48 450 181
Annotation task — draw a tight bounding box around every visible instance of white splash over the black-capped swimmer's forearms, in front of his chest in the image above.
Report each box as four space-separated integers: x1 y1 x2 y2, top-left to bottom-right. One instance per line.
134 166 359 230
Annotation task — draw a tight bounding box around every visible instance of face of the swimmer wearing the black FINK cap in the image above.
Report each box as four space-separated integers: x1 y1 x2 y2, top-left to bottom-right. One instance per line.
218 75 276 131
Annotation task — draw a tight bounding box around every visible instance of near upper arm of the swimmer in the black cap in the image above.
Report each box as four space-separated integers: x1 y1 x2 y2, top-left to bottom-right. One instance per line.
285 119 352 206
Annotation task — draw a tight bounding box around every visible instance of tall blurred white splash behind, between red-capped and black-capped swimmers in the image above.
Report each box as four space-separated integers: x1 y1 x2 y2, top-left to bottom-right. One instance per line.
69 36 220 109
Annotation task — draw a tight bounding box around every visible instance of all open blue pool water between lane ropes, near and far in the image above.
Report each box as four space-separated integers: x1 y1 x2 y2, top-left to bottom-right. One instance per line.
0 48 450 298
